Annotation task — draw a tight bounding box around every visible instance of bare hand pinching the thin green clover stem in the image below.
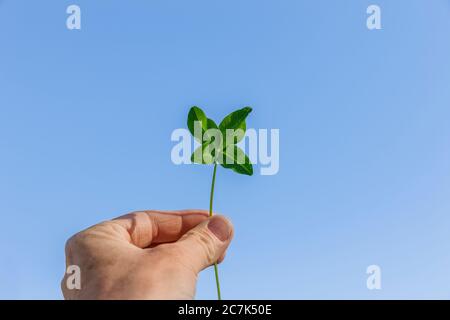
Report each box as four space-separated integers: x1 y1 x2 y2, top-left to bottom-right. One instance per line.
61 210 233 300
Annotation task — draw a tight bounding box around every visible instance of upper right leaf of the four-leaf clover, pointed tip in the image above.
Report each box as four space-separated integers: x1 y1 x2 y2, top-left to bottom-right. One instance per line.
219 107 252 145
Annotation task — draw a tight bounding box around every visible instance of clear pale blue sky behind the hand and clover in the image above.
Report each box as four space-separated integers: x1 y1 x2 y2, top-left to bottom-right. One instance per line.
0 0 450 299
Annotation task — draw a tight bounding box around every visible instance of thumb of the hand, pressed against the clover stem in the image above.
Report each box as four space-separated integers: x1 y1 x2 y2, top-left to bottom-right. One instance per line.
174 216 233 272
